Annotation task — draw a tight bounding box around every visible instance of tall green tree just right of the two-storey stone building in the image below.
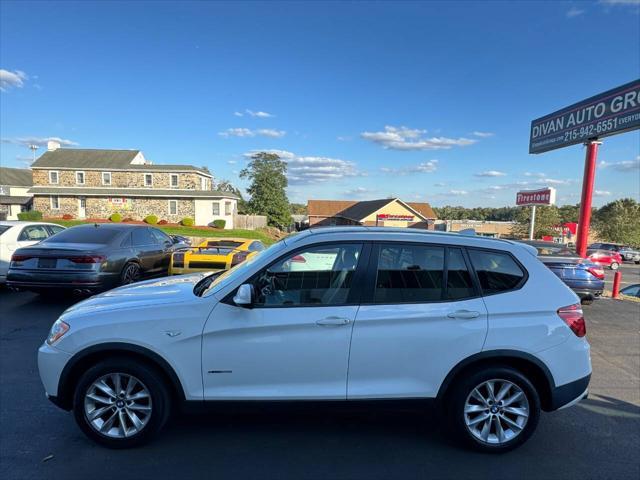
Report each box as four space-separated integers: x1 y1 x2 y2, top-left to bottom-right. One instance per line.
240 152 291 229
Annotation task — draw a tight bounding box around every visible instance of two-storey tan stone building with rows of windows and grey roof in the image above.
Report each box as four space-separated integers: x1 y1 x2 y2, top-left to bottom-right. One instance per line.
29 142 238 228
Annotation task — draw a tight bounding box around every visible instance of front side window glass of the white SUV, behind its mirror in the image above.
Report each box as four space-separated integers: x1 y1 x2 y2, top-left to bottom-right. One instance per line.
251 244 362 307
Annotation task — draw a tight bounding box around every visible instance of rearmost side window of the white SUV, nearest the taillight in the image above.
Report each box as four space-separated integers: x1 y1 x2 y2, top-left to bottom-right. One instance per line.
469 250 524 294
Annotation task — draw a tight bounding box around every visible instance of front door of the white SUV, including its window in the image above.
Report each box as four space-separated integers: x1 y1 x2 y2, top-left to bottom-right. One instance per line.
202 243 368 400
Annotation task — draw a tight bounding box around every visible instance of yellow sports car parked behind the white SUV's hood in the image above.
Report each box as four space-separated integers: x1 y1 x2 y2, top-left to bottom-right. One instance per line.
169 238 264 275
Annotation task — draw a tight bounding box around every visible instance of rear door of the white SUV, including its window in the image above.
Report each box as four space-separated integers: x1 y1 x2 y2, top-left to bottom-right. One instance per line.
347 242 487 399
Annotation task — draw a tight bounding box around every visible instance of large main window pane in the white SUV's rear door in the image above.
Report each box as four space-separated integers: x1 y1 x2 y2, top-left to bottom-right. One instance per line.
374 244 444 303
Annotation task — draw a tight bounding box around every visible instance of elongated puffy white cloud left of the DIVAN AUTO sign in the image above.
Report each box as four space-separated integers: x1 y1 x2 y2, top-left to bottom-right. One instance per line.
360 125 476 150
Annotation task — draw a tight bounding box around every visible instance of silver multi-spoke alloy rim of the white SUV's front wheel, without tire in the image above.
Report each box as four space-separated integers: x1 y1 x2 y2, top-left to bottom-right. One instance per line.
84 373 152 438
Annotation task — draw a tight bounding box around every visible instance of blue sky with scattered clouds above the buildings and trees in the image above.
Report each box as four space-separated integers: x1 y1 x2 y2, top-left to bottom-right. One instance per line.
0 0 640 206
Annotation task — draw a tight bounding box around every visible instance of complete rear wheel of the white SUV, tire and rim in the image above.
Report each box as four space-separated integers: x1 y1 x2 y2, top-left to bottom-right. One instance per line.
449 367 540 453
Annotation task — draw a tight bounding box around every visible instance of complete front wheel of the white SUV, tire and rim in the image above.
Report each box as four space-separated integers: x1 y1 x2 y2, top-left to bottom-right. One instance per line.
73 359 170 448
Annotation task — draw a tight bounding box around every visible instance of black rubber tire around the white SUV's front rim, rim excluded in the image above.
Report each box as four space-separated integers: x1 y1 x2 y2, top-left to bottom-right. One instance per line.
73 358 171 449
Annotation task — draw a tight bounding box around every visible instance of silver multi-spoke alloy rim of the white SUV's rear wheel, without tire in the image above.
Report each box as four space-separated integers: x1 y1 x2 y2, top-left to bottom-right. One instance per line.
464 379 530 445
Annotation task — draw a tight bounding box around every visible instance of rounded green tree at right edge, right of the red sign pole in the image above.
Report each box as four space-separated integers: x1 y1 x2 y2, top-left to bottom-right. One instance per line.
593 198 640 247
